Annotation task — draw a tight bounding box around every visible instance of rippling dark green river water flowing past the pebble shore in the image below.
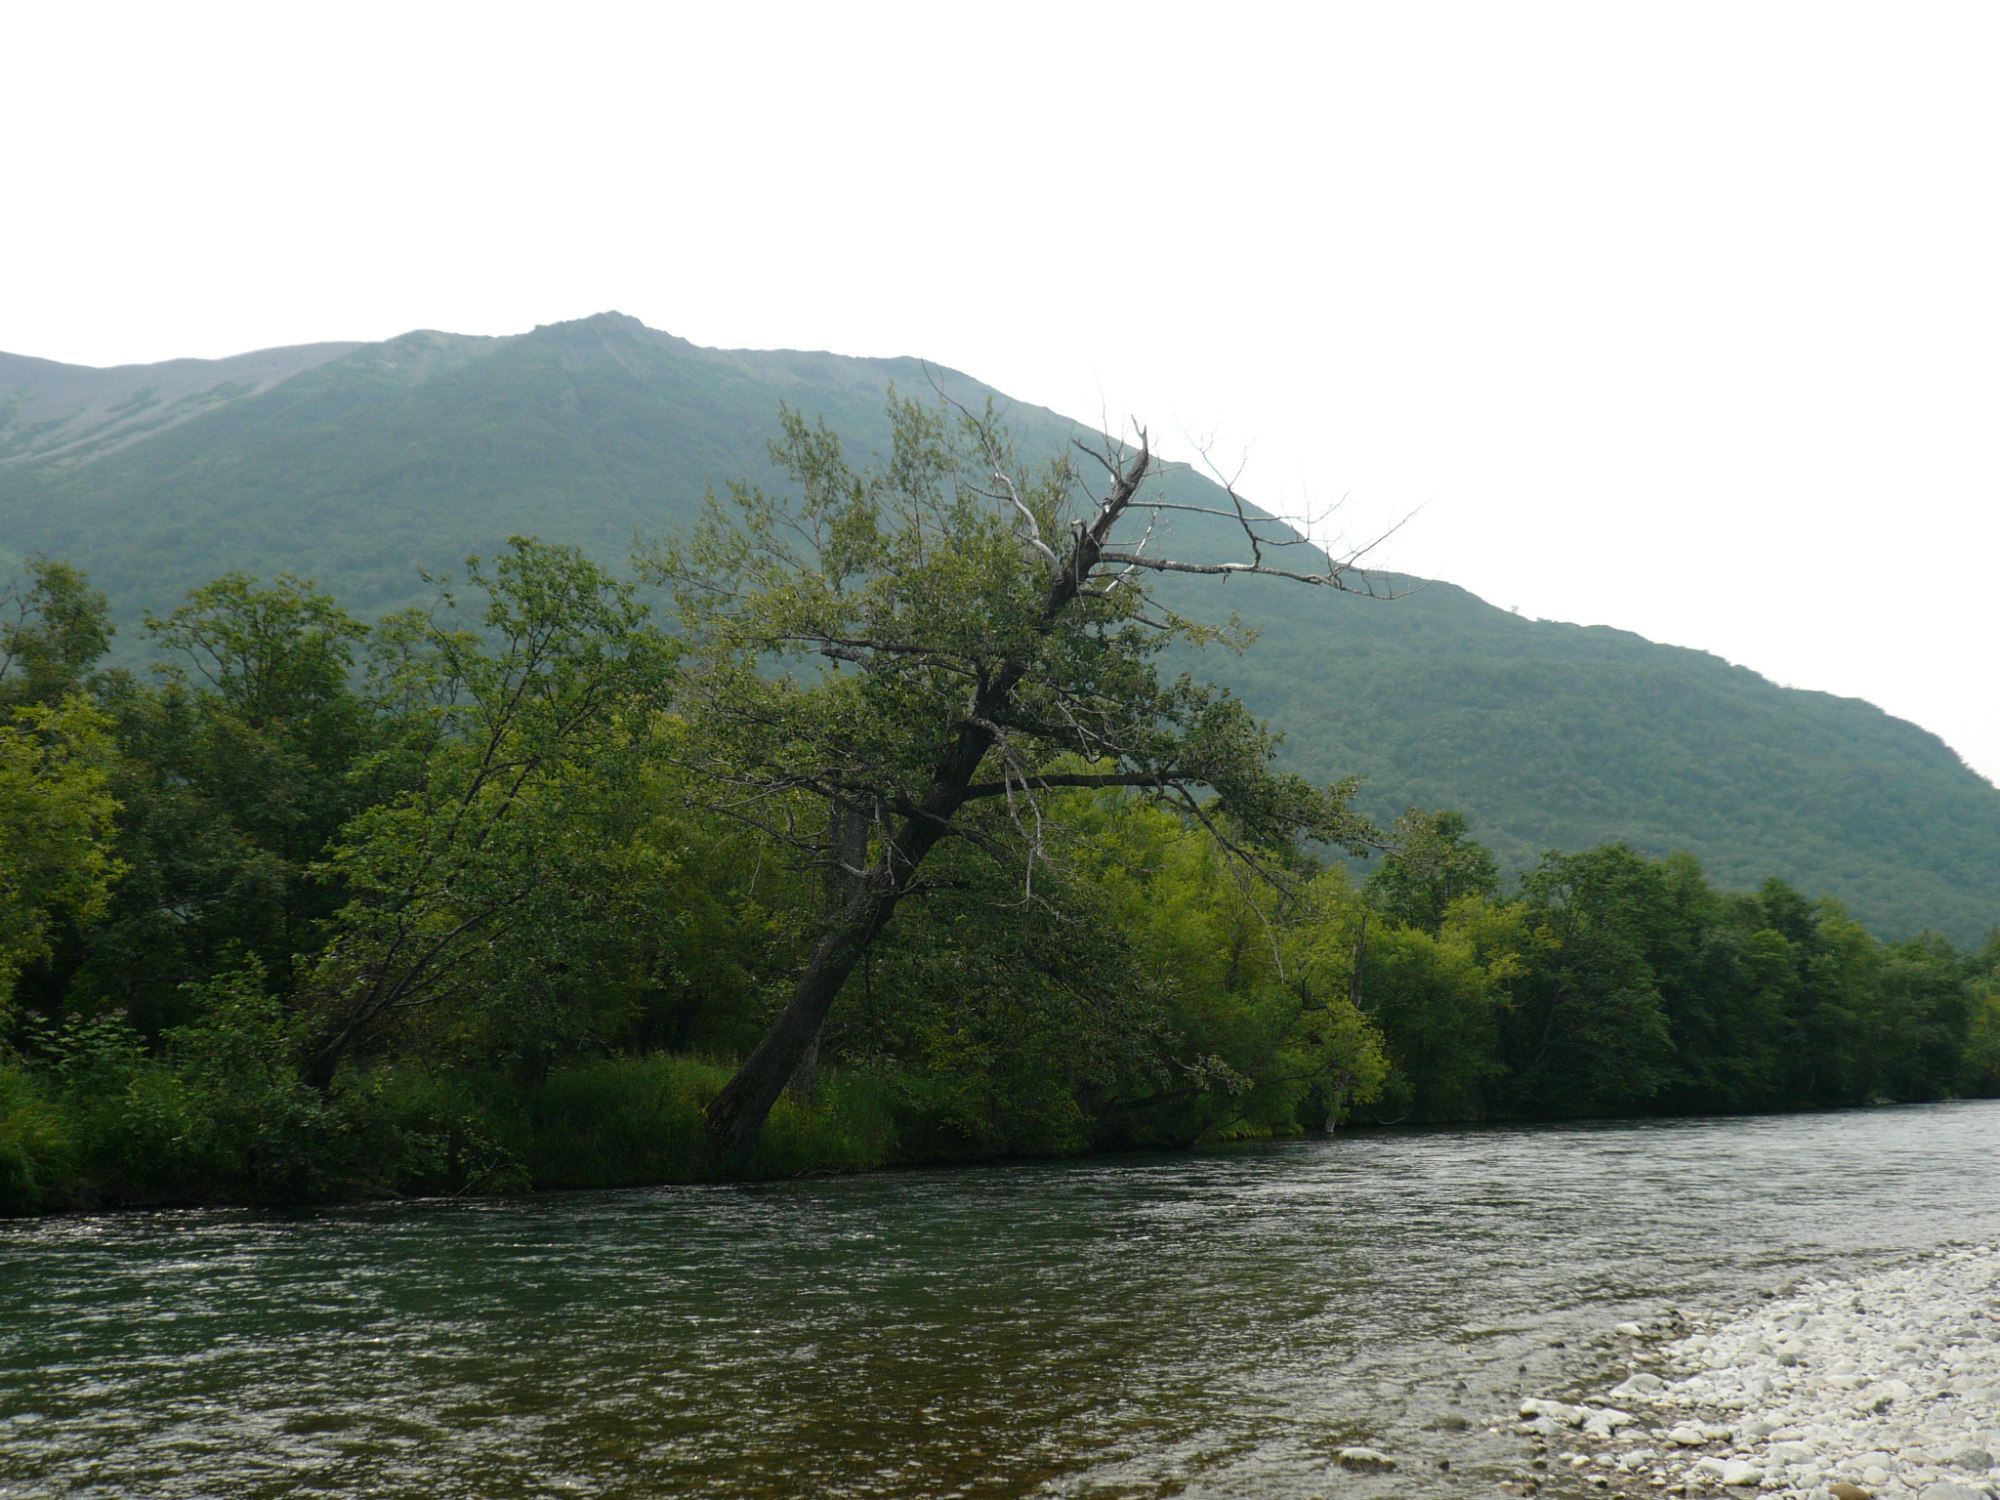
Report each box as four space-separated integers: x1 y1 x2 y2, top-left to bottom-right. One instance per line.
0 1102 2000 1500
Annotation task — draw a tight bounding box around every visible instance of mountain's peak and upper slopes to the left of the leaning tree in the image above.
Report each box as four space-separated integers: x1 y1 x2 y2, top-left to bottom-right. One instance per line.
0 314 924 618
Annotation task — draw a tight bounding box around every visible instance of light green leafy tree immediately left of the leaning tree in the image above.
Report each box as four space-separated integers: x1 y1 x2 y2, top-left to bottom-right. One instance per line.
304 538 672 1088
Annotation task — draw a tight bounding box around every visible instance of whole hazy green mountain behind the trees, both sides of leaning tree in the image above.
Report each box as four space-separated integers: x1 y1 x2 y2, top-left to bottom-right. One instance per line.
0 314 2000 942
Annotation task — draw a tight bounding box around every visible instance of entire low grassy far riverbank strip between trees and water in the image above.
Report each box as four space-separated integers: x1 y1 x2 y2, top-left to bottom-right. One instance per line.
0 1048 1992 1220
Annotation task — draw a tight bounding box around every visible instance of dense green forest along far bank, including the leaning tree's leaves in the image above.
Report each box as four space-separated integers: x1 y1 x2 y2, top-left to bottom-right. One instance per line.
0 404 2000 1212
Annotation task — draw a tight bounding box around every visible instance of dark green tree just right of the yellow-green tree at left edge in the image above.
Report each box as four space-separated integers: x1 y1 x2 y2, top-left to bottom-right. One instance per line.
60 574 384 1036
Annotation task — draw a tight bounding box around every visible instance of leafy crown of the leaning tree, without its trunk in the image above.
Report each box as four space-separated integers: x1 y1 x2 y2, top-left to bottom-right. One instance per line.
642 394 1364 876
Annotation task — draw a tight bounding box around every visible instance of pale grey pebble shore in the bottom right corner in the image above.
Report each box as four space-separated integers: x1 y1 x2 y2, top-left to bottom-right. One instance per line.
1494 1246 2000 1500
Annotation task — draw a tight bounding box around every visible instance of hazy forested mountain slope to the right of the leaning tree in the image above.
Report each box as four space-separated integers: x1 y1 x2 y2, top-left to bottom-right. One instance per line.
1216 582 2000 944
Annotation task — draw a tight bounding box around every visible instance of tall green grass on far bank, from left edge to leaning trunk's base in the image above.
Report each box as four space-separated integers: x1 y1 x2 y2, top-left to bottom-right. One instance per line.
0 1050 920 1214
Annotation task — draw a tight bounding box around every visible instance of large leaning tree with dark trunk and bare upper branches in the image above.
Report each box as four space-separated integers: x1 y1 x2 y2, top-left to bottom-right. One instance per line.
640 394 1374 1152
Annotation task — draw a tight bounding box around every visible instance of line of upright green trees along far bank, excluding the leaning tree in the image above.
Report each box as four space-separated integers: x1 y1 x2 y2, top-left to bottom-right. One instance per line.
0 556 2000 1212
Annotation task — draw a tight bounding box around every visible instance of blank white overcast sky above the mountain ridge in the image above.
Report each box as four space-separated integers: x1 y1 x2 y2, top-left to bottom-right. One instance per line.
11 0 2000 776
